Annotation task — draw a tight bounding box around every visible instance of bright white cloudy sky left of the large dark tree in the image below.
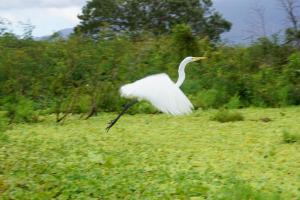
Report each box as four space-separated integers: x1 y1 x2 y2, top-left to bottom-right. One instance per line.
0 0 86 36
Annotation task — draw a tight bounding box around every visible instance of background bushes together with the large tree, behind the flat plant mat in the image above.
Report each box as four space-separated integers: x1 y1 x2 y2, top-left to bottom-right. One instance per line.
0 0 300 123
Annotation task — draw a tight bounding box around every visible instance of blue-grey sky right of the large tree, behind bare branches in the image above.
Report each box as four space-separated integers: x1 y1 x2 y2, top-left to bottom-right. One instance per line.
213 0 287 42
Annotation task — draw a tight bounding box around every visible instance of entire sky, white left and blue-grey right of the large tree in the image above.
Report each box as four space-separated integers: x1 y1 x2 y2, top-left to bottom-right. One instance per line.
0 0 290 41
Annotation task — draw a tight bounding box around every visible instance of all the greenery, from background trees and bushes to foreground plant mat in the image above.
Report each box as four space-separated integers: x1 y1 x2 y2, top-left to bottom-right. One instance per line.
0 0 300 200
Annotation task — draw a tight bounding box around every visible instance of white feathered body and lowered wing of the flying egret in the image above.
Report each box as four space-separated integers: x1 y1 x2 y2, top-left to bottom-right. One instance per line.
120 74 193 115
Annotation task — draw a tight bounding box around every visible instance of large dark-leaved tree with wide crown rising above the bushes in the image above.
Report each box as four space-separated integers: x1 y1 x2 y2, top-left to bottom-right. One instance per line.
76 0 231 40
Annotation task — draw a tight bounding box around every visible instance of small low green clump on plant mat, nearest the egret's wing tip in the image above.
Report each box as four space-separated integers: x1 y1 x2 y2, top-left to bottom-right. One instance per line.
212 109 244 123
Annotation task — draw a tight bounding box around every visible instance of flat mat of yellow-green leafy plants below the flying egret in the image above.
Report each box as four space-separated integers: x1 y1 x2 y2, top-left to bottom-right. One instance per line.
0 107 300 200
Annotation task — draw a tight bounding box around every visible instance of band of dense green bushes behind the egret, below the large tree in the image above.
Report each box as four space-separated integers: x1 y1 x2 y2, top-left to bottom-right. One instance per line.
0 24 300 120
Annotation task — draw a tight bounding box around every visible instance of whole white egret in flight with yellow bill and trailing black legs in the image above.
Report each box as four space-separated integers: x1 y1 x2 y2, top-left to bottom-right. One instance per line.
106 57 206 131
